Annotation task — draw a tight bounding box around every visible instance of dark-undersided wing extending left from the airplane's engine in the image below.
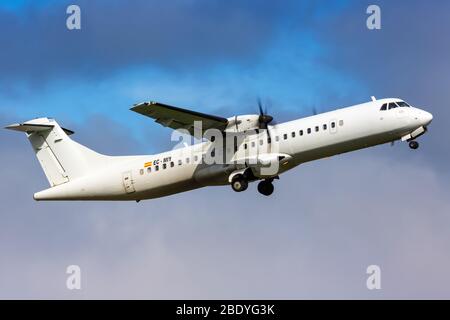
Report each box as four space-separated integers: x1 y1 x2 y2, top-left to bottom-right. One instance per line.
131 101 228 135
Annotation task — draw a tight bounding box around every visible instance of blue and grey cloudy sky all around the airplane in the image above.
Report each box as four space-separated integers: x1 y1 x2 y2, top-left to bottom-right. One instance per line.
0 0 450 299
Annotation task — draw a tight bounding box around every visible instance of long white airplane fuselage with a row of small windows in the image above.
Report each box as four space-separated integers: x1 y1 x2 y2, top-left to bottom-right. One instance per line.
34 99 432 200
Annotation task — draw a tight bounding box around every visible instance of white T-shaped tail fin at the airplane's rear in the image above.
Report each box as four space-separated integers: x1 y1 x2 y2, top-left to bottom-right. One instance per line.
6 118 108 187
